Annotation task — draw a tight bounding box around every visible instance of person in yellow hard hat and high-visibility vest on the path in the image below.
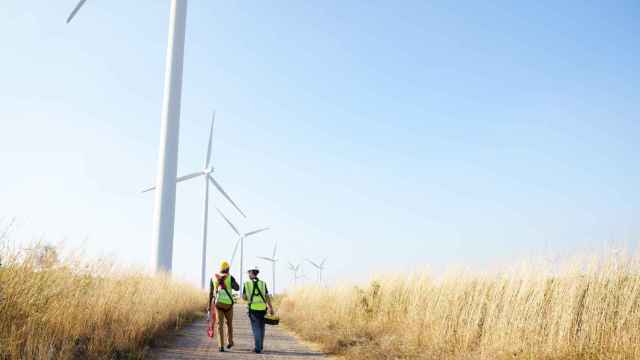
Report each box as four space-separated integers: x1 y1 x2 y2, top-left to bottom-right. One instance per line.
209 261 240 352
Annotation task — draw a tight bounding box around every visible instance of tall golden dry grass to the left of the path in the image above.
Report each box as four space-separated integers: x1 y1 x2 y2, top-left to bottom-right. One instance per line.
0 243 206 359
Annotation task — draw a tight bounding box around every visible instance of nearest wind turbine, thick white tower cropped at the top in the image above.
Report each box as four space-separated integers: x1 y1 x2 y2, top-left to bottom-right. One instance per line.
67 0 187 272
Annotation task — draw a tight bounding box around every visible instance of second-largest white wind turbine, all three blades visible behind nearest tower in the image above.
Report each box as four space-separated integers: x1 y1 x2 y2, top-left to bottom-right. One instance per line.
142 111 246 289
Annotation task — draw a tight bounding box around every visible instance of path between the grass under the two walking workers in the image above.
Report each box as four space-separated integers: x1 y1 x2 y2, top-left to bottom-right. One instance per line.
151 305 324 360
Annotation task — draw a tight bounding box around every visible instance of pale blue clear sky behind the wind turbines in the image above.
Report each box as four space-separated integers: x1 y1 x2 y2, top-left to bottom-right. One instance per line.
0 0 640 287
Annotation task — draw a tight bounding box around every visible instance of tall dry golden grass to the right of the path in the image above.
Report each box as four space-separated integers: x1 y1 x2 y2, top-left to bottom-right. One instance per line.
281 258 640 359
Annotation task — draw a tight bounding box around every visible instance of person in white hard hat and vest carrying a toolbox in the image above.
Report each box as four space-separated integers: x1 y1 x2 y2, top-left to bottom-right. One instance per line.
242 267 273 354
